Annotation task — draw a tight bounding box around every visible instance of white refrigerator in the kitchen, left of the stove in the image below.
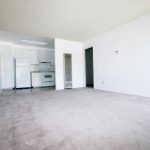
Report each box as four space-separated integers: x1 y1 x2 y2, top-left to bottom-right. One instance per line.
16 59 31 88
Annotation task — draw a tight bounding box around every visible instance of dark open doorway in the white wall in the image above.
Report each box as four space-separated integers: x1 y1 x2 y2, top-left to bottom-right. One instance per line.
85 47 94 87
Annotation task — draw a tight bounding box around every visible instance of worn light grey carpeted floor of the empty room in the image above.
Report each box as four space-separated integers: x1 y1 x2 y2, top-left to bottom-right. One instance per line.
0 88 150 150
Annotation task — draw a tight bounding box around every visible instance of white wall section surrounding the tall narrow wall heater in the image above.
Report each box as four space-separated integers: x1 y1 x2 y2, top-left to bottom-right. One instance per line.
55 39 85 90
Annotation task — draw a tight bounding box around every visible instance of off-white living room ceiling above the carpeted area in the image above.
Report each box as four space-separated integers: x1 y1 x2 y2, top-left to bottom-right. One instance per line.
0 0 150 41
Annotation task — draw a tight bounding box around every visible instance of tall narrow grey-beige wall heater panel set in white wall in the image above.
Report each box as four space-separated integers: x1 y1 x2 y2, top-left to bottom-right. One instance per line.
64 54 72 89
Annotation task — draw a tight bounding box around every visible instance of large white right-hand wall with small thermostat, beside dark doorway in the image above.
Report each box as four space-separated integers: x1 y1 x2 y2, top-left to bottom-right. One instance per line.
84 14 150 96
